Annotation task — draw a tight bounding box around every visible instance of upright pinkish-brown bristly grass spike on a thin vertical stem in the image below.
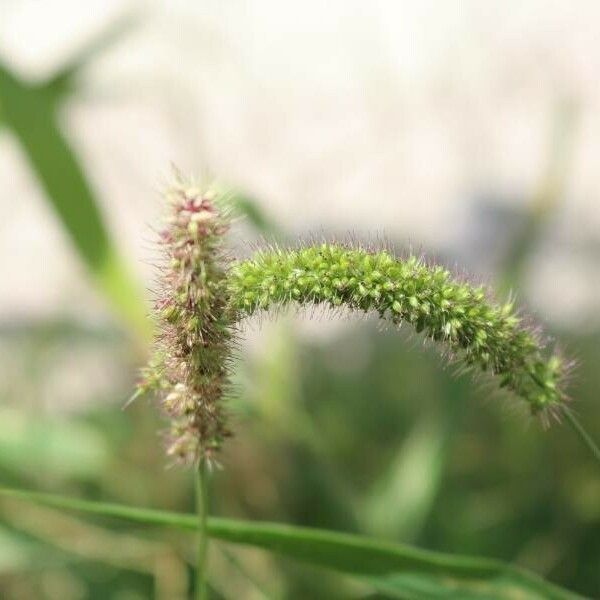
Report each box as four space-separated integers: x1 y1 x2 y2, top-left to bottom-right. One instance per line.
138 181 231 463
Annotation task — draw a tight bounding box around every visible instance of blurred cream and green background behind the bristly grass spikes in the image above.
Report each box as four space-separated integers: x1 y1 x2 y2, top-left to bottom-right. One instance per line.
0 0 600 600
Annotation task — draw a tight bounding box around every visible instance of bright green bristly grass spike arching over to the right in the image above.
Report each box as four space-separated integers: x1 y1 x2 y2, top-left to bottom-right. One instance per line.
228 243 565 420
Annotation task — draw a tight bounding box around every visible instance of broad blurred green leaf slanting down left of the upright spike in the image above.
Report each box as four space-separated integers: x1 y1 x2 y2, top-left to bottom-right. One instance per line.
0 65 150 337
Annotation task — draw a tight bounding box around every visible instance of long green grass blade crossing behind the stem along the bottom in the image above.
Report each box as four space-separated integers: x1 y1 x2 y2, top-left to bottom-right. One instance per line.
0 489 578 599
